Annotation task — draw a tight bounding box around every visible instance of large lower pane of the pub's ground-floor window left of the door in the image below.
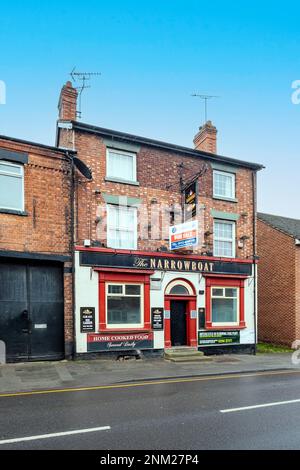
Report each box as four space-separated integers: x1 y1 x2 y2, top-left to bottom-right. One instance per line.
107 297 141 325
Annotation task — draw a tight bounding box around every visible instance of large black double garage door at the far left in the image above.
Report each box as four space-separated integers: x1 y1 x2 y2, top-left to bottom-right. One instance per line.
0 262 64 362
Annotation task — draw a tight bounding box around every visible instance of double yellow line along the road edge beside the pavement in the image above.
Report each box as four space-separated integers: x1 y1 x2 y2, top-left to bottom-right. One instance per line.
0 370 300 398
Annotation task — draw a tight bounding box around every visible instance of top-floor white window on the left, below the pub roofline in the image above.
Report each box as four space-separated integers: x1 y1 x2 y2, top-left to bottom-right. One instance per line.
106 149 136 183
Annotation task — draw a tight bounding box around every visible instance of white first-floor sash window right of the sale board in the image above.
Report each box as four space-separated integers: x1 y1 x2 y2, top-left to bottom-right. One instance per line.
214 220 235 258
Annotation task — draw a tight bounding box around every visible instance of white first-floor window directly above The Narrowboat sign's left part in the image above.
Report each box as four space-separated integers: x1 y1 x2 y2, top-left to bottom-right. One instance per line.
107 204 137 250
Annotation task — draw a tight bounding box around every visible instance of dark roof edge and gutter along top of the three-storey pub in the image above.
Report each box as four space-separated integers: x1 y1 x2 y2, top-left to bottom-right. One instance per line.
72 121 264 171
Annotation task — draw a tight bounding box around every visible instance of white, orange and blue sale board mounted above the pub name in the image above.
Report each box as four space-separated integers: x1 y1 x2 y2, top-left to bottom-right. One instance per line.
169 220 198 250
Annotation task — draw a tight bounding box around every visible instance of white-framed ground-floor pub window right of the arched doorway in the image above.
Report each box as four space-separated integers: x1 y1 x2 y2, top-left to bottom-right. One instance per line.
211 287 239 325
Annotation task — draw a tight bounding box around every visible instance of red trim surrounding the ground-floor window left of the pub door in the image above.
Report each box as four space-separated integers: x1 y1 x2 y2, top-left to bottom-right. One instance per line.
99 270 152 333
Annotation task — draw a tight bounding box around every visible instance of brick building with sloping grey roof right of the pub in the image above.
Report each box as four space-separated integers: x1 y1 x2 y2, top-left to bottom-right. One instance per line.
257 213 300 346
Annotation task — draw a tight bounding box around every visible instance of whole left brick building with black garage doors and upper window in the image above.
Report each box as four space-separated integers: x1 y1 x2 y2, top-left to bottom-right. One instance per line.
0 136 74 361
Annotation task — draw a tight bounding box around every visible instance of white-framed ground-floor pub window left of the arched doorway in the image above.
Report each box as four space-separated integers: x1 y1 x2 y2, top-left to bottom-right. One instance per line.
106 284 144 328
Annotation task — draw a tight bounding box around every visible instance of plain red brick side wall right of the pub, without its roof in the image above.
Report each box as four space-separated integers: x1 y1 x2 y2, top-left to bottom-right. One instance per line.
257 220 300 346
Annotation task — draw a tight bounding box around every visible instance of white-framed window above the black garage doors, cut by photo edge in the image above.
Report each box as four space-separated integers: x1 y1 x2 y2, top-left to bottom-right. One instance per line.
0 161 24 211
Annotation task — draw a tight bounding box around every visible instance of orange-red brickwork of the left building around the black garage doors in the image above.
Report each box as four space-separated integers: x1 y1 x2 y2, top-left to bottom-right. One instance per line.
0 139 73 352
